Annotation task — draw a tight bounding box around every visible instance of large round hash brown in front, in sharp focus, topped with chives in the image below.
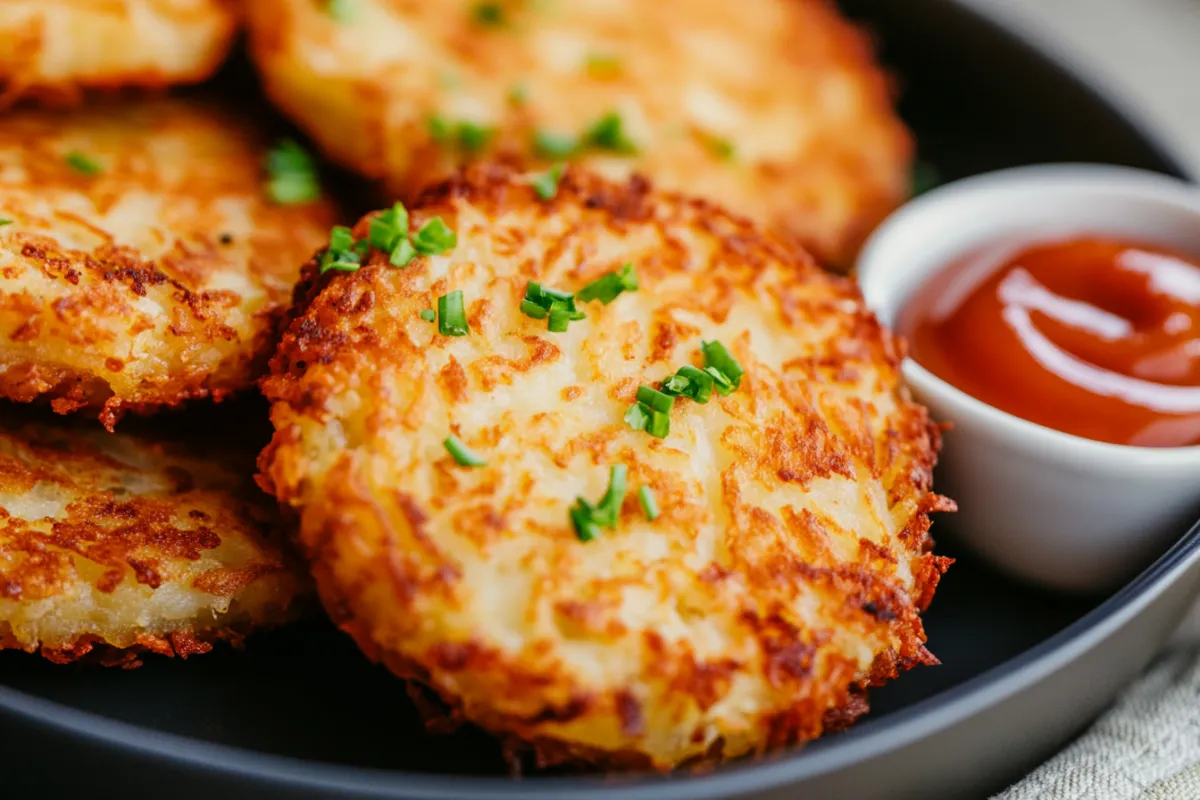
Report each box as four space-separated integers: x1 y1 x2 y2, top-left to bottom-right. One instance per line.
259 166 953 769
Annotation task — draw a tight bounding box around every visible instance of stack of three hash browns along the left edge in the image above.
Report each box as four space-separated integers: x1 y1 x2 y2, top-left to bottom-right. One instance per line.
0 31 334 666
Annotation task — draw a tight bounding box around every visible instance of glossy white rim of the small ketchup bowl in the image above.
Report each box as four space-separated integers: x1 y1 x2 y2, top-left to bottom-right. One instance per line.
857 162 1200 462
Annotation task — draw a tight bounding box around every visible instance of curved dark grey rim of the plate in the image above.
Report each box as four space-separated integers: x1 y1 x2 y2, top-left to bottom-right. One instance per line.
0 0 1200 800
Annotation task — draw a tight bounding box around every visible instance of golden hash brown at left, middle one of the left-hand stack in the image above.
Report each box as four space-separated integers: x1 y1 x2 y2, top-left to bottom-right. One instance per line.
0 101 334 429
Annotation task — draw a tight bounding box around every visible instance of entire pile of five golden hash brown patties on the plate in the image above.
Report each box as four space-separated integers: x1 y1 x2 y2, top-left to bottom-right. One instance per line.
0 0 953 770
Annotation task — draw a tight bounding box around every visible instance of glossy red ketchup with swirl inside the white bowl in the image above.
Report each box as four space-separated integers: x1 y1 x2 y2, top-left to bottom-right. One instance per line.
900 237 1200 447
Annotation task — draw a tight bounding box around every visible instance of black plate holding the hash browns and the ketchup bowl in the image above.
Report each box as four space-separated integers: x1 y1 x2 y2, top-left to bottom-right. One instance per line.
0 0 1200 800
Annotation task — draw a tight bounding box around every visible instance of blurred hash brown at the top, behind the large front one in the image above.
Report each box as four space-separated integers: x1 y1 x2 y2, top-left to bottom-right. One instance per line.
247 0 913 266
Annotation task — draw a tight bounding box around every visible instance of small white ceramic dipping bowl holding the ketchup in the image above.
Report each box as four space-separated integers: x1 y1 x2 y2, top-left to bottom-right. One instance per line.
858 164 1200 590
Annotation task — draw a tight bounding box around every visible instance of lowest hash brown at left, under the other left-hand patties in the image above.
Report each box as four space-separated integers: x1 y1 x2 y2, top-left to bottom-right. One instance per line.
0 417 310 666
